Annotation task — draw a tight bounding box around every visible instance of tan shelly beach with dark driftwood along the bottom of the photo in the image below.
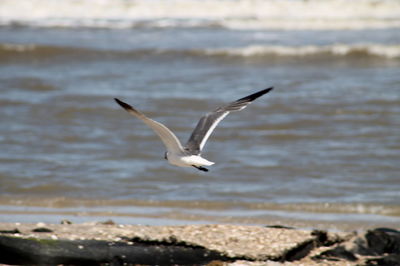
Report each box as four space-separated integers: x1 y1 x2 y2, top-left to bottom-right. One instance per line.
0 220 400 265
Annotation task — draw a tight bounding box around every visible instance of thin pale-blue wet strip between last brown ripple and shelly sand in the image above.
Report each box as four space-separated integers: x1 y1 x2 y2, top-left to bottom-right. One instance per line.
0 206 399 232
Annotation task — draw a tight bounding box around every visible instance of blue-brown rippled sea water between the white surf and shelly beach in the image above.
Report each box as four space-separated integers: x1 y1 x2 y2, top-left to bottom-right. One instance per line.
0 0 400 229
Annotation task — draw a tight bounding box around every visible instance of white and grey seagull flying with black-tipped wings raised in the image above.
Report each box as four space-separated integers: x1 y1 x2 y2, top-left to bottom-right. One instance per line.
114 87 273 172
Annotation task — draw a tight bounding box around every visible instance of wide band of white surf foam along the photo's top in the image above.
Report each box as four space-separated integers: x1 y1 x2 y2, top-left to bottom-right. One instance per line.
0 0 400 29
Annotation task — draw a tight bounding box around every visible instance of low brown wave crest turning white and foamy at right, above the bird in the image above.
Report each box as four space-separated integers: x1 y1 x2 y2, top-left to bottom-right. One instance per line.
0 44 400 60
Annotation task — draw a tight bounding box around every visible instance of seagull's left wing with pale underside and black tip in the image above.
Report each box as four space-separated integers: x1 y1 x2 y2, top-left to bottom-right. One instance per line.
114 98 183 152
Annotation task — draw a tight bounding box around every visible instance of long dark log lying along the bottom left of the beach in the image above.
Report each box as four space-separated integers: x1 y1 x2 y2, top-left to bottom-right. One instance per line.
0 236 229 265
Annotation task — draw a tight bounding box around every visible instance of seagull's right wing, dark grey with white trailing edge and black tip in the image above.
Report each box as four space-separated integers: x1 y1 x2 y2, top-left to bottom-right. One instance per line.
185 87 273 154
